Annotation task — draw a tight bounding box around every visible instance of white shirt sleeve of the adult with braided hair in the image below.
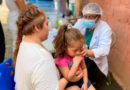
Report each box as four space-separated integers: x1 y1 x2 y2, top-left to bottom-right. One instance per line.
31 60 58 90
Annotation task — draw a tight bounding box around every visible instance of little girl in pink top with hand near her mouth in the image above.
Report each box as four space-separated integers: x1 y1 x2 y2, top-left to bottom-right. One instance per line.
54 25 95 90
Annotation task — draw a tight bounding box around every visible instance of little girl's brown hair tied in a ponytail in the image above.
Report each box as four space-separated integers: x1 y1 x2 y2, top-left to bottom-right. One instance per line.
53 25 84 57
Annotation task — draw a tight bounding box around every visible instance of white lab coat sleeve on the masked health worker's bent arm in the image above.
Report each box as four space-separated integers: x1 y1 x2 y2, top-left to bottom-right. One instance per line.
92 28 112 58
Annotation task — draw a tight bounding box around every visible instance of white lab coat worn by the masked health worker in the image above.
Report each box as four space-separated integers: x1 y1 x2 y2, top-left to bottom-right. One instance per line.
75 20 112 76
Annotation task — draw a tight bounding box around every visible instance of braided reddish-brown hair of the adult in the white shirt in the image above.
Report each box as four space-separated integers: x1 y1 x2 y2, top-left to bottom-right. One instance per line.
13 4 46 64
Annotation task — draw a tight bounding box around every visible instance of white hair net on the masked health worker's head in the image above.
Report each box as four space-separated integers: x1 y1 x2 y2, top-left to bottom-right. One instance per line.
82 3 103 15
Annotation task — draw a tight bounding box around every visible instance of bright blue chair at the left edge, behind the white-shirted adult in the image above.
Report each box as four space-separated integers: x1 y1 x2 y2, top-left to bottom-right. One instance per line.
0 58 15 90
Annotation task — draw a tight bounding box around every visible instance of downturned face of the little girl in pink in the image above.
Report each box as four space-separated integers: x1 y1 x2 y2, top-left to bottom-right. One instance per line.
67 41 83 57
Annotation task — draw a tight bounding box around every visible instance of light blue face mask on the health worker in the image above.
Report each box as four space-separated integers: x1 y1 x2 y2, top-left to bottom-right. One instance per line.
82 19 96 29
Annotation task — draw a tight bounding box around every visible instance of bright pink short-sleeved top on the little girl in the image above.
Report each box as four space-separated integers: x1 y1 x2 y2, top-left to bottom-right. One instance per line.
55 55 84 68
